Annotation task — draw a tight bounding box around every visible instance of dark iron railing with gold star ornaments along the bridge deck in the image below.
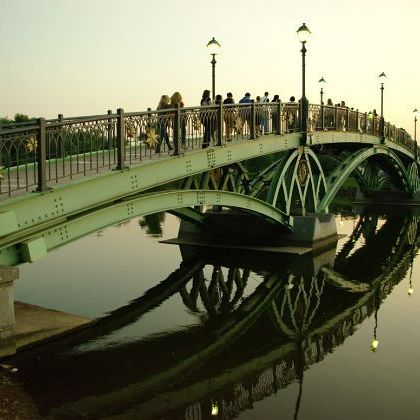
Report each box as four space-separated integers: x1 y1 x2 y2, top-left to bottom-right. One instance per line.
0 102 416 197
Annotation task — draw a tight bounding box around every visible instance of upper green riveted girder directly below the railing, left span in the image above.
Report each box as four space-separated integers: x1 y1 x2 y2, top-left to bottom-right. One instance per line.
0 133 300 240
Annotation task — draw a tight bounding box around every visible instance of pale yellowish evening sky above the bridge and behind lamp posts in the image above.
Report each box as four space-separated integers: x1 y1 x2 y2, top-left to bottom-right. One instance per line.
0 0 420 134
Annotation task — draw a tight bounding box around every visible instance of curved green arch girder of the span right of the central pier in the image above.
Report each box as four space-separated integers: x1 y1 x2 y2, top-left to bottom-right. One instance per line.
318 146 412 211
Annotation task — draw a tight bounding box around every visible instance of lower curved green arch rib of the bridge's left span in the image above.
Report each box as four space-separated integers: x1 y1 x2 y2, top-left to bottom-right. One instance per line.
0 190 293 265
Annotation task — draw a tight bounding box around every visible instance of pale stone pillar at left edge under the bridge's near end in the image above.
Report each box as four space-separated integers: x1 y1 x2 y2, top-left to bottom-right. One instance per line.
0 266 19 357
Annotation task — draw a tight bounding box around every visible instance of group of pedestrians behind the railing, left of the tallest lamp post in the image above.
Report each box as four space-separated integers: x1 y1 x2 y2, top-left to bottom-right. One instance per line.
155 89 280 153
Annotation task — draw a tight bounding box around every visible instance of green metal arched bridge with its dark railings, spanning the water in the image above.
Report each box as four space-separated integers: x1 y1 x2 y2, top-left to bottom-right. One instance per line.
0 102 420 266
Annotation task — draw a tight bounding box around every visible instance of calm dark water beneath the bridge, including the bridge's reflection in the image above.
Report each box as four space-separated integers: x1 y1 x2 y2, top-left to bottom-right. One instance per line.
12 208 420 419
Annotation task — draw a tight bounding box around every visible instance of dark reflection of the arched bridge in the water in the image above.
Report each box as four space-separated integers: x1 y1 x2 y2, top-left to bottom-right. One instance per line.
8 215 419 418
